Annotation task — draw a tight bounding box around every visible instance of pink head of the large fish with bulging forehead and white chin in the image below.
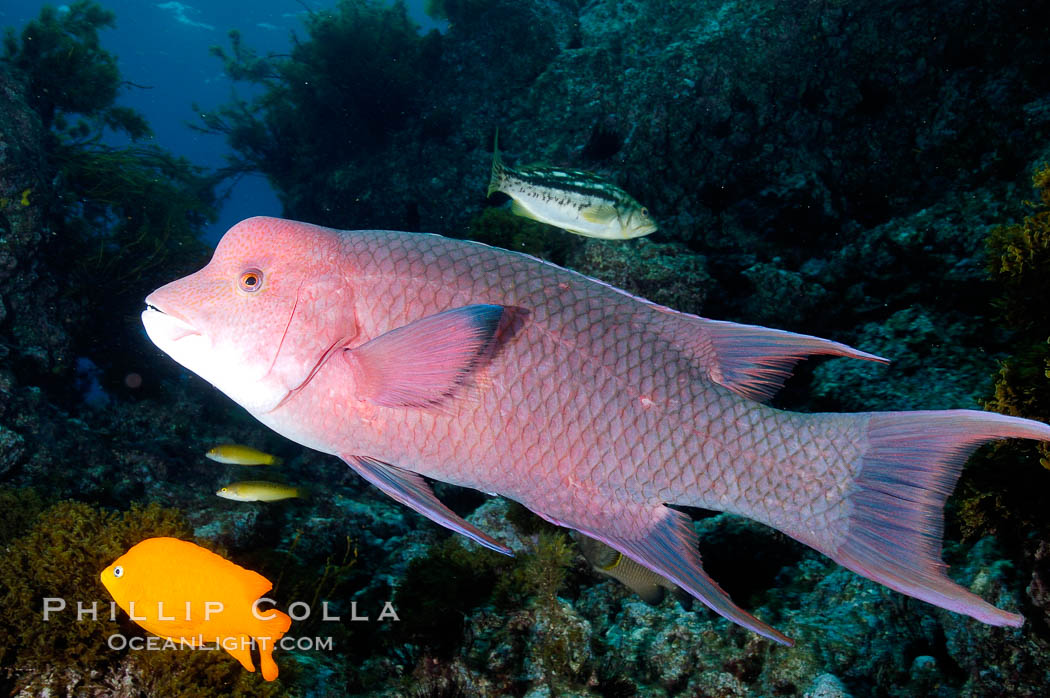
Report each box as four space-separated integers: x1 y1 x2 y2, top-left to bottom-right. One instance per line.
142 217 357 414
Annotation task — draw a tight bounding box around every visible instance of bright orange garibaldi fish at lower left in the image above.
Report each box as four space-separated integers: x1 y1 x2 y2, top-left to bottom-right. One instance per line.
101 538 292 681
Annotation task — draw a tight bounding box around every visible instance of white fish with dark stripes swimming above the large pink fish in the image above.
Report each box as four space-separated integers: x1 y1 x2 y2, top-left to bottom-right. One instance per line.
488 133 656 240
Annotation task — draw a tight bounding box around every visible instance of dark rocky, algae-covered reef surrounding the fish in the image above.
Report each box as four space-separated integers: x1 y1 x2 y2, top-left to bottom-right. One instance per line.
0 0 1050 697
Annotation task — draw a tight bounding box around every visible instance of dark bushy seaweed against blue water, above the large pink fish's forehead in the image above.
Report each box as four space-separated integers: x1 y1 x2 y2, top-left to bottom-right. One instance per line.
201 0 440 225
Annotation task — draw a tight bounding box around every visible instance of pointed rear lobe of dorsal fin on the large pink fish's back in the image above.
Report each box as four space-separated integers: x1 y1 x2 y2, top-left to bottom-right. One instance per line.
683 316 889 402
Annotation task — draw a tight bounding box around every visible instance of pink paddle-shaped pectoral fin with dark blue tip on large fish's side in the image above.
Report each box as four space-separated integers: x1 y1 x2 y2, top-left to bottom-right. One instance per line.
342 305 503 407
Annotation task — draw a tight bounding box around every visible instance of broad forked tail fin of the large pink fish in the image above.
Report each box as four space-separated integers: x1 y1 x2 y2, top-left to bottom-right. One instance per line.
827 409 1050 627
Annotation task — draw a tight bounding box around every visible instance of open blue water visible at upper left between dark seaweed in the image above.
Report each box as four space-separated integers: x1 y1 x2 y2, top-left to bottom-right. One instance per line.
0 0 443 242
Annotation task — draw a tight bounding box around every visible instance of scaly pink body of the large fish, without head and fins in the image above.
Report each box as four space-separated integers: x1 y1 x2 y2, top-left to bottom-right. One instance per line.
275 225 865 544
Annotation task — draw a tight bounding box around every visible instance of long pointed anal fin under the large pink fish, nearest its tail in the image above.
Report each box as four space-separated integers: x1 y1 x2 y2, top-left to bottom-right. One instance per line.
584 505 795 647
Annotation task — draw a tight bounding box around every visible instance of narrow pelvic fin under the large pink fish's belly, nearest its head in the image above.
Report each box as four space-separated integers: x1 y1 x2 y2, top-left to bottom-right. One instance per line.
342 456 513 555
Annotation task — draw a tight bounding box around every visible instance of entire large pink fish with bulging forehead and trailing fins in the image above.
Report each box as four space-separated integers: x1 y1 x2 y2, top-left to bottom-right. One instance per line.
143 217 1050 644
